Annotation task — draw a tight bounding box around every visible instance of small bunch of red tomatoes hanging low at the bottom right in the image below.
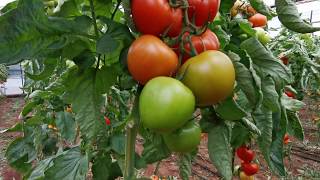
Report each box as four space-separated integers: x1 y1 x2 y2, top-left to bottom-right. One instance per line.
236 145 259 180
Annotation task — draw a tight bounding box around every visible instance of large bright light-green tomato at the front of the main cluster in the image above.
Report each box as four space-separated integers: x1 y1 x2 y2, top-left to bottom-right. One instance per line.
139 77 195 133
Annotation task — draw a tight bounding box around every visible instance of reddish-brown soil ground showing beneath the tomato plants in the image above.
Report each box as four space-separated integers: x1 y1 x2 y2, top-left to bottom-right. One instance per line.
0 98 320 180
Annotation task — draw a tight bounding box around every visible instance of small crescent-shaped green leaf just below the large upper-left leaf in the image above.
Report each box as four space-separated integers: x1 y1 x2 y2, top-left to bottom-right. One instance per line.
25 58 58 81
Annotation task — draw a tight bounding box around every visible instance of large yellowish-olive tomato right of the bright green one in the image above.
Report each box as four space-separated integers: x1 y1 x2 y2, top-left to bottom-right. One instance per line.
178 50 235 106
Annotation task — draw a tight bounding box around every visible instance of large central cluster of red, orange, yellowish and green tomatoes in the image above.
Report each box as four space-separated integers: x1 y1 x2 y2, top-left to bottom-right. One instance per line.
127 0 235 152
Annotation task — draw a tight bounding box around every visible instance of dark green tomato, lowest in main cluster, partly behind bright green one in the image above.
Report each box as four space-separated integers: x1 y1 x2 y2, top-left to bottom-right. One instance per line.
163 122 201 153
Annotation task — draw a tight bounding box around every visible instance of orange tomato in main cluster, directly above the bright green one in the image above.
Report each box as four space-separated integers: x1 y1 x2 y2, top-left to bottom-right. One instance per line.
127 35 179 84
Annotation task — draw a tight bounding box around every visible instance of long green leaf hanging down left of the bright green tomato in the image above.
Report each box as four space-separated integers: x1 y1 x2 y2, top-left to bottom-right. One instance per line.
64 68 104 140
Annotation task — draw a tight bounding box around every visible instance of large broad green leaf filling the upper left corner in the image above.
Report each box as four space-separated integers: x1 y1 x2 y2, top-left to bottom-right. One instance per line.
0 0 92 64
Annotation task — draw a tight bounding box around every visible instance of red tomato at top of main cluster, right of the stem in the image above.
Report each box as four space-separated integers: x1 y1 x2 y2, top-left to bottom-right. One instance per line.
188 0 220 26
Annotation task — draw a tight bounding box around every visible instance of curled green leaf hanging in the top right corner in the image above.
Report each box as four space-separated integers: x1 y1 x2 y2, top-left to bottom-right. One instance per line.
275 0 320 33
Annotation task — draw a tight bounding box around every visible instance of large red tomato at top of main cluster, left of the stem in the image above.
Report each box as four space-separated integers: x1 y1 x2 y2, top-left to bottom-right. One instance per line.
131 0 183 37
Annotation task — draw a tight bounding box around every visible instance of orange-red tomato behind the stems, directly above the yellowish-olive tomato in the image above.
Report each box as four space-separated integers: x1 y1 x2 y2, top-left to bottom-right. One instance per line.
182 29 220 63
